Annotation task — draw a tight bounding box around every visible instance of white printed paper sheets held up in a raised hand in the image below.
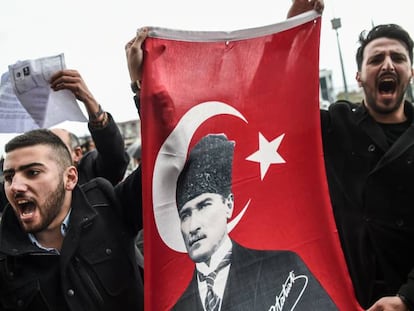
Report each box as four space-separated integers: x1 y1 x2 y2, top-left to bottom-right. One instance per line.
0 54 87 133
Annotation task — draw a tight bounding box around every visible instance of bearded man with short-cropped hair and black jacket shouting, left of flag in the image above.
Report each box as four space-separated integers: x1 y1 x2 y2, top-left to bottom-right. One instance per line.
0 129 143 311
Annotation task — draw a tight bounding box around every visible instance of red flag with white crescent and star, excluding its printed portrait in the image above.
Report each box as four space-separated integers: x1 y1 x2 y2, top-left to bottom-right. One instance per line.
141 12 360 311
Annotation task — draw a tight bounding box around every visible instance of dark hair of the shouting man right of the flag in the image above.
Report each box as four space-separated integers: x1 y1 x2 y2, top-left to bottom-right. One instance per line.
356 24 413 71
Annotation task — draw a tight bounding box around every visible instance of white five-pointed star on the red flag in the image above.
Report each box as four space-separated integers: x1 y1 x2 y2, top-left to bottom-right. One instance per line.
246 132 286 180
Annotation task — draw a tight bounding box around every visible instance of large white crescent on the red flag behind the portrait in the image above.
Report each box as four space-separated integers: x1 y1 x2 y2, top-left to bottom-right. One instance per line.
152 101 249 253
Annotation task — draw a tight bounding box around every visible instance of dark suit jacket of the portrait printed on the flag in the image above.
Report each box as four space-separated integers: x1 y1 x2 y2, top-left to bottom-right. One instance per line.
172 242 338 311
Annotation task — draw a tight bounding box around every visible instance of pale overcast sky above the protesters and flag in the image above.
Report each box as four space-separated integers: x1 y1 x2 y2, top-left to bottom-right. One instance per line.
0 0 414 151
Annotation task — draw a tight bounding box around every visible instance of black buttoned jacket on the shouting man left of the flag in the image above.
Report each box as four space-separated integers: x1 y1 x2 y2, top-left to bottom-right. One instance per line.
0 171 143 311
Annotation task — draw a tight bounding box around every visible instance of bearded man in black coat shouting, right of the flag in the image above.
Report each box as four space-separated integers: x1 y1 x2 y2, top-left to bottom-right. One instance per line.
321 24 414 311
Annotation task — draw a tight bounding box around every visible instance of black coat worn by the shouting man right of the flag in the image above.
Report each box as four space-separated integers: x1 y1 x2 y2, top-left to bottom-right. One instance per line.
321 102 414 308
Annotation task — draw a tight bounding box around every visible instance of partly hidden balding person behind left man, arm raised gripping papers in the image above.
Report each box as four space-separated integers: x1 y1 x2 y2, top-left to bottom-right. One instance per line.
0 69 129 215
